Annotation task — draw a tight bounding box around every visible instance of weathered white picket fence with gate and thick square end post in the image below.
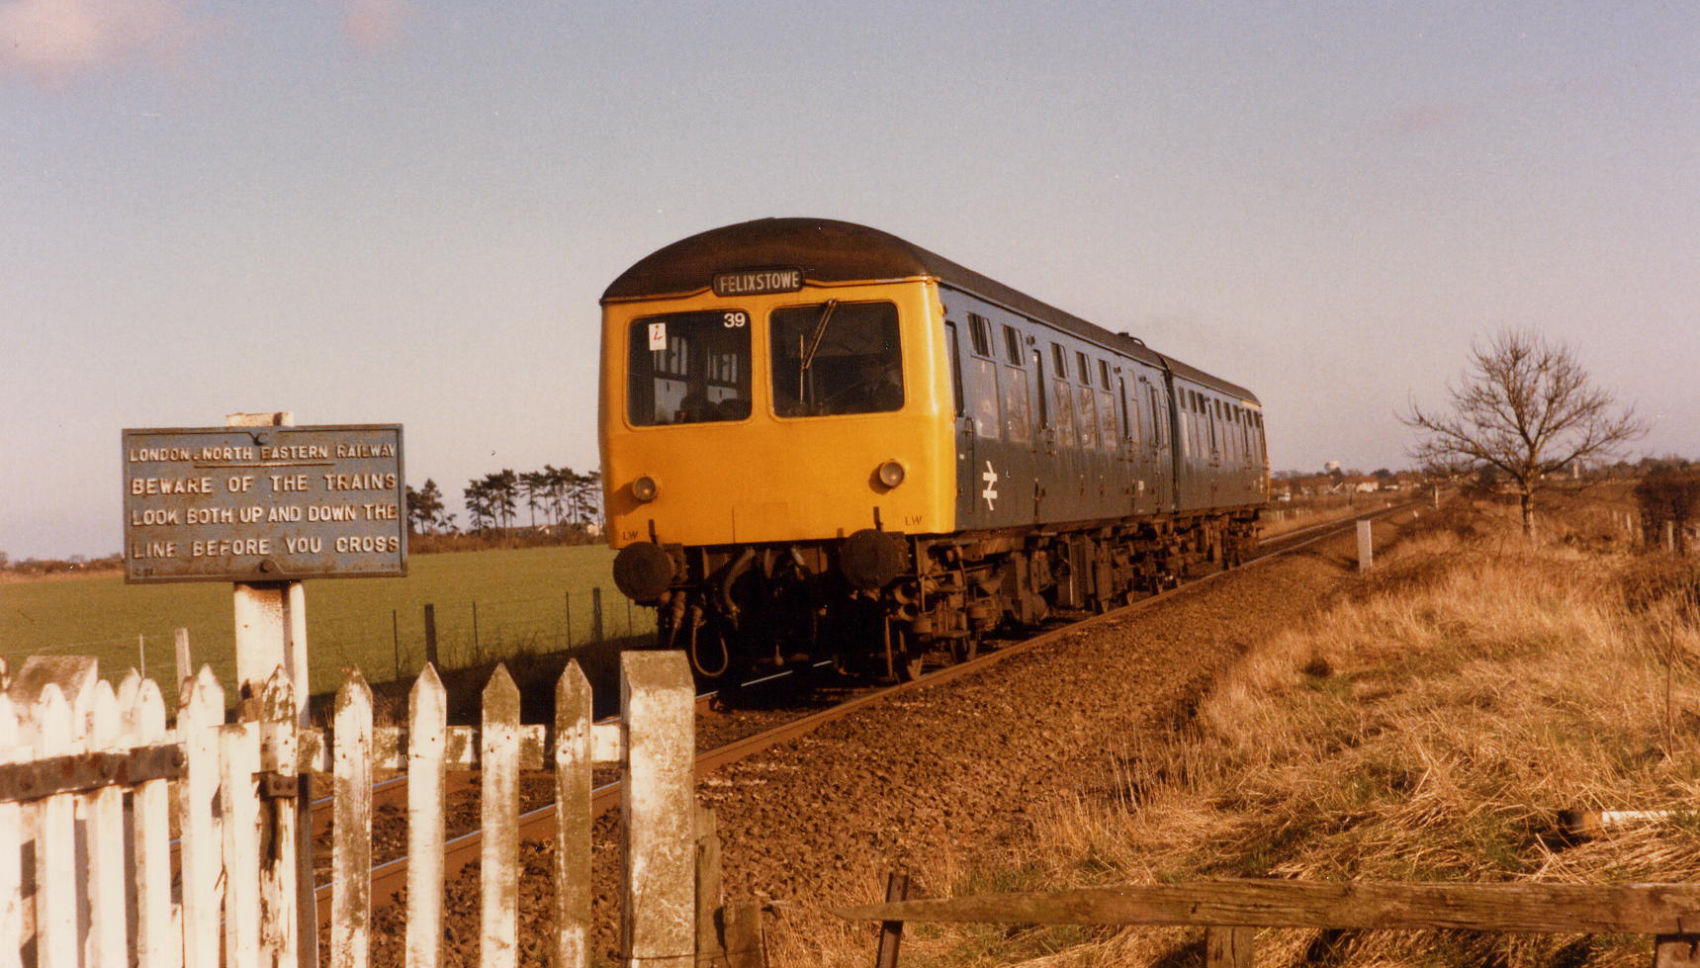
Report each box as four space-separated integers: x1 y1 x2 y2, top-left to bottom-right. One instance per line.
0 652 741 968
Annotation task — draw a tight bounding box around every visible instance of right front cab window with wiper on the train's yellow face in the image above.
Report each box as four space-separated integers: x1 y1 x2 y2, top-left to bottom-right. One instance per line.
768 299 903 417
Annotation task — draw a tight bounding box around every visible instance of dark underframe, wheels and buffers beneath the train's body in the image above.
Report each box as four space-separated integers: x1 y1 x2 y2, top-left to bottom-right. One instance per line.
615 507 1258 682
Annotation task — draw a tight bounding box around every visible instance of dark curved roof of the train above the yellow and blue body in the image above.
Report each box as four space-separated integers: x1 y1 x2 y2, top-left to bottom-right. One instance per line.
602 218 1258 403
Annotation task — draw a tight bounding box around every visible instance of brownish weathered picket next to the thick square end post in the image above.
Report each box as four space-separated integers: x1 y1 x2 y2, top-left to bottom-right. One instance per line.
554 660 592 968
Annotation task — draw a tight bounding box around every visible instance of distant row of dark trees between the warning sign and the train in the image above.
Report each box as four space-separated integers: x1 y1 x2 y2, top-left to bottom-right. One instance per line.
408 464 602 534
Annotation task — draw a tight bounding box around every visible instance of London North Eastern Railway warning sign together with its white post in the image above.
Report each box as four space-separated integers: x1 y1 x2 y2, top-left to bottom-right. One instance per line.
122 412 408 968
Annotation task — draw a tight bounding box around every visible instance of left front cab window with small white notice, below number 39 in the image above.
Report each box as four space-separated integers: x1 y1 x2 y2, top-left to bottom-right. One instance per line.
626 310 750 427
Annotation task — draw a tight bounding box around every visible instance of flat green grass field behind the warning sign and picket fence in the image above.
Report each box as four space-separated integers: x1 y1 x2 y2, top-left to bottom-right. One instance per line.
0 544 655 703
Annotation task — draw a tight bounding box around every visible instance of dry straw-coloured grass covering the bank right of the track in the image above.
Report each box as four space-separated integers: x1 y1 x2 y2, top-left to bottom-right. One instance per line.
870 507 1700 968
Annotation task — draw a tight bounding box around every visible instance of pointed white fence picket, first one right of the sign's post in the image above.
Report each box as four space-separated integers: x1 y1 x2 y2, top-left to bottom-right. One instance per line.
330 670 372 968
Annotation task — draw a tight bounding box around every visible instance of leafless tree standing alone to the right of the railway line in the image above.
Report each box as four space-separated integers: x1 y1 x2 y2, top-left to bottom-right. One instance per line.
1401 330 1647 534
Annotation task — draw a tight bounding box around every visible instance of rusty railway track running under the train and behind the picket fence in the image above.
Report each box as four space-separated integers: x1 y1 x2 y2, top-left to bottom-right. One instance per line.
313 500 1426 924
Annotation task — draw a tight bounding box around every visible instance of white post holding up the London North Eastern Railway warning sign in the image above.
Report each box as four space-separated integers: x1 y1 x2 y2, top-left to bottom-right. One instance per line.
226 410 318 968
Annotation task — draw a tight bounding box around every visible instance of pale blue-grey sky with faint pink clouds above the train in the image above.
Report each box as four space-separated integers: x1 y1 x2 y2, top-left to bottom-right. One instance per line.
0 0 1700 558
